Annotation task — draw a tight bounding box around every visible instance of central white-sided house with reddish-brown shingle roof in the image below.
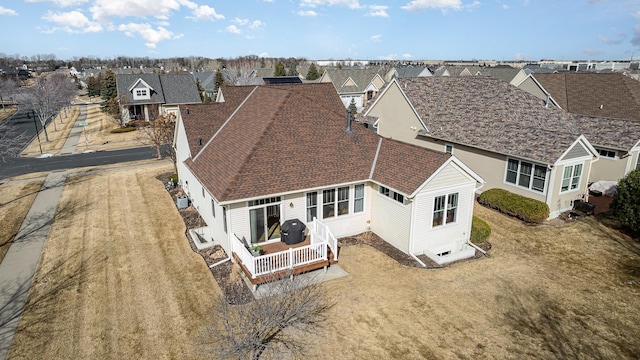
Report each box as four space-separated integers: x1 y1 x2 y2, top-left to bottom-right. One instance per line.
175 83 483 272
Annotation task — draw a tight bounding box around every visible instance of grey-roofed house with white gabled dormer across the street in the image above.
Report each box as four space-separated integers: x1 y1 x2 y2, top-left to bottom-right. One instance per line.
116 73 201 121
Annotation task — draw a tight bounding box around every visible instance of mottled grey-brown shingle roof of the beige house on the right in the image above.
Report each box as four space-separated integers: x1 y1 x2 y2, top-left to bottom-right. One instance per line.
398 76 580 164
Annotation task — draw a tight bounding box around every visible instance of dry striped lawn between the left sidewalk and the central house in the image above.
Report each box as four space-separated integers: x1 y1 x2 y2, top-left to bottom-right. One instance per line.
9 163 220 359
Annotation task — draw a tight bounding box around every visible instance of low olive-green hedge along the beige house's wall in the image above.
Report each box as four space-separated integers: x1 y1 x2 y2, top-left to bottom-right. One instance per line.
478 189 549 223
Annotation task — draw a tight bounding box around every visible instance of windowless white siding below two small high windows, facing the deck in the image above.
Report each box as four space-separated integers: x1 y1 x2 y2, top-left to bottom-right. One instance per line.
371 188 412 253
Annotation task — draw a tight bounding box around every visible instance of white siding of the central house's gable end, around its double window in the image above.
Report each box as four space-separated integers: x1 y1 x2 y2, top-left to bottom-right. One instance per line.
412 183 475 255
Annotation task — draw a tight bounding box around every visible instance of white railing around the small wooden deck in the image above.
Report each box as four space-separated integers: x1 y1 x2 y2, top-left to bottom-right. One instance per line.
231 218 338 279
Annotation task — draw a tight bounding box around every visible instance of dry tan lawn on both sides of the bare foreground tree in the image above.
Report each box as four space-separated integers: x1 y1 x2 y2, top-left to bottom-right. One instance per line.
5 165 640 359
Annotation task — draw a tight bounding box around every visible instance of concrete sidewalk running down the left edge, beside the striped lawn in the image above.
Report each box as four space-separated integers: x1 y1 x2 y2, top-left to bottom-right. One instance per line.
0 172 67 360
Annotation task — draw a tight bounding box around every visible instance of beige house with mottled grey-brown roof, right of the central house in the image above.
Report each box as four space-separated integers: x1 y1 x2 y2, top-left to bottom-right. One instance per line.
363 76 598 218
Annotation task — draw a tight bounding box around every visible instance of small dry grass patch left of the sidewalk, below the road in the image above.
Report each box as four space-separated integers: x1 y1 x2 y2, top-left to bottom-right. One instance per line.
0 179 43 262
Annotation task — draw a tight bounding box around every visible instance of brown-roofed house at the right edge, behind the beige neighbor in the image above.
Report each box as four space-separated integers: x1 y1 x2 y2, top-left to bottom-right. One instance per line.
519 72 640 182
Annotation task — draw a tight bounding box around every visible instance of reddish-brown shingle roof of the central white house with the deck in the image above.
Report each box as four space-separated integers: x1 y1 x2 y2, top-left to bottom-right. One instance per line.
182 83 458 202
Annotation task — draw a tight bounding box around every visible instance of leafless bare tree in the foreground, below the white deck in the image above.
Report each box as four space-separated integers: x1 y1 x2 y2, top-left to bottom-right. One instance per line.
200 276 335 359
